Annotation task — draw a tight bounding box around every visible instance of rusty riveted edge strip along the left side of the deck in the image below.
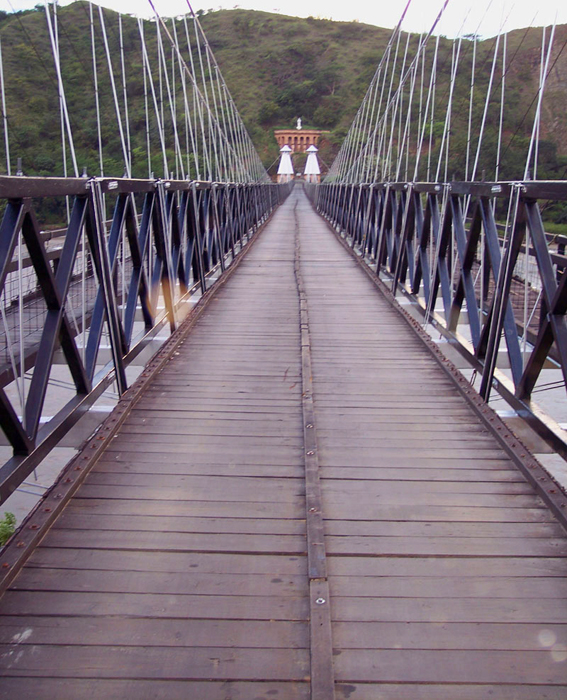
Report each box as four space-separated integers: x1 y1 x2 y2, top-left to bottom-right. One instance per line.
0 211 272 597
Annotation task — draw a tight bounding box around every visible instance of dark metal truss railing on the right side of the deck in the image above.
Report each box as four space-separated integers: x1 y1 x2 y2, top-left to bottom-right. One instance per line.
307 181 567 458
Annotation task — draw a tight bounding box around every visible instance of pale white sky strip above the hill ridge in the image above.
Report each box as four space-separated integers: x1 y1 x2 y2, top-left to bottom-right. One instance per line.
0 0 567 36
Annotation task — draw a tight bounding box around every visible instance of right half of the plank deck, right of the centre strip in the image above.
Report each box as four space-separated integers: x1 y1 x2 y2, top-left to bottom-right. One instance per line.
300 193 567 700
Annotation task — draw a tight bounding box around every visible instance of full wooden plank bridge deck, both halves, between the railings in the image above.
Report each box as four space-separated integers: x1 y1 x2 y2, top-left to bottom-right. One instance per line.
0 190 567 700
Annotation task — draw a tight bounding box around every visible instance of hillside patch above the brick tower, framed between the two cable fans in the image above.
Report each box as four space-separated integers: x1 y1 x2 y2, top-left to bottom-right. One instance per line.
201 10 391 166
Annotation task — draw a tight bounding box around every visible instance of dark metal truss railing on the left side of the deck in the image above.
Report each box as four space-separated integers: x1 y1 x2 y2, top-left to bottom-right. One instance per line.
0 177 289 501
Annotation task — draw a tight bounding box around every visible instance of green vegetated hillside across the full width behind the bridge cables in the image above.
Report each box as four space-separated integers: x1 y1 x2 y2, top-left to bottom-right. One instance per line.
0 2 567 191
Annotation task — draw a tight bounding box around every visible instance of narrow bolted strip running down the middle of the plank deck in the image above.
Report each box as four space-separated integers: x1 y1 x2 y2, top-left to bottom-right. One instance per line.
293 203 335 700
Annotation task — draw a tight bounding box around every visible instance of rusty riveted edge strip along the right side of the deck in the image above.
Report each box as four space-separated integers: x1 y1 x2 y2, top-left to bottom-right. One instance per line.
311 203 567 530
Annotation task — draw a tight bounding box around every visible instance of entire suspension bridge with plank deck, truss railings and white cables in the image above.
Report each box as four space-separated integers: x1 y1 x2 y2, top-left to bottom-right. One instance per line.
0 3 567 700
